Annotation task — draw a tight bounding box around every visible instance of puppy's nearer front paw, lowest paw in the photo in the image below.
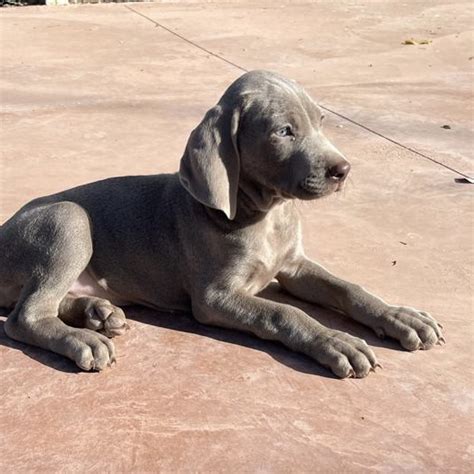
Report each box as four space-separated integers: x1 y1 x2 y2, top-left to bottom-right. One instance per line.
314 329 381 378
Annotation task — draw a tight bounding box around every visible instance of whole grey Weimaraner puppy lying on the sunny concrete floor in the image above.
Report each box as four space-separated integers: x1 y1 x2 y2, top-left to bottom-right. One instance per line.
0 71 444 378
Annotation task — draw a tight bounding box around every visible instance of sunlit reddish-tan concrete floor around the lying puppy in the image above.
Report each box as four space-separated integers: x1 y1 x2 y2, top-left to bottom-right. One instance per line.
0 0 474 473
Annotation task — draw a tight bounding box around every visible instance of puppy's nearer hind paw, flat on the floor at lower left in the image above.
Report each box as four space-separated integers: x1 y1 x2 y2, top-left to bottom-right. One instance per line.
61 328 115 371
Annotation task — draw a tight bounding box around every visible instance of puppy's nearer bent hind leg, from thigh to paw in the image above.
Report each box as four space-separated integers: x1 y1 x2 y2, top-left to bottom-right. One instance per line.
0 202 115 370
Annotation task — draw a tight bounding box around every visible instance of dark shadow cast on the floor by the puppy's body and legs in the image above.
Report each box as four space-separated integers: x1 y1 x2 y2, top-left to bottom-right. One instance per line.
0 283 400 378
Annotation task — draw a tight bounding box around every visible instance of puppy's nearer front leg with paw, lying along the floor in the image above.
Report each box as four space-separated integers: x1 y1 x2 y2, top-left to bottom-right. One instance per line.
193 290 378 378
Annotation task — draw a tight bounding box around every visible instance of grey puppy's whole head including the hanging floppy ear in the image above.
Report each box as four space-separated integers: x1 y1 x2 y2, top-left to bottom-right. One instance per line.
179 71 350 219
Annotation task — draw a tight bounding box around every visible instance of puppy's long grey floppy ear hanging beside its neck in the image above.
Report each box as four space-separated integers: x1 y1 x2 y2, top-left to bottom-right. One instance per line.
179 104 240 220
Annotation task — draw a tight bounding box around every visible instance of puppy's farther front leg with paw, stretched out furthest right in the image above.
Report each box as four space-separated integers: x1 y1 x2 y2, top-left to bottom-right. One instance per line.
277 256 444 351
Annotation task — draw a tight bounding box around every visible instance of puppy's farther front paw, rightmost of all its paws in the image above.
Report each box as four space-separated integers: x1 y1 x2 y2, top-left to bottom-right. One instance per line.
374 306 446 351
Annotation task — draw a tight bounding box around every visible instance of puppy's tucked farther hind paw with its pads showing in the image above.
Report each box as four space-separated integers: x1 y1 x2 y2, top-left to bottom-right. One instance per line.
84 298 129 337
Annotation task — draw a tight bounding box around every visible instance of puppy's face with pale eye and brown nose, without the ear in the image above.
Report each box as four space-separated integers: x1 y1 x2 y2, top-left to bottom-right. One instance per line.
237 75 350 199
